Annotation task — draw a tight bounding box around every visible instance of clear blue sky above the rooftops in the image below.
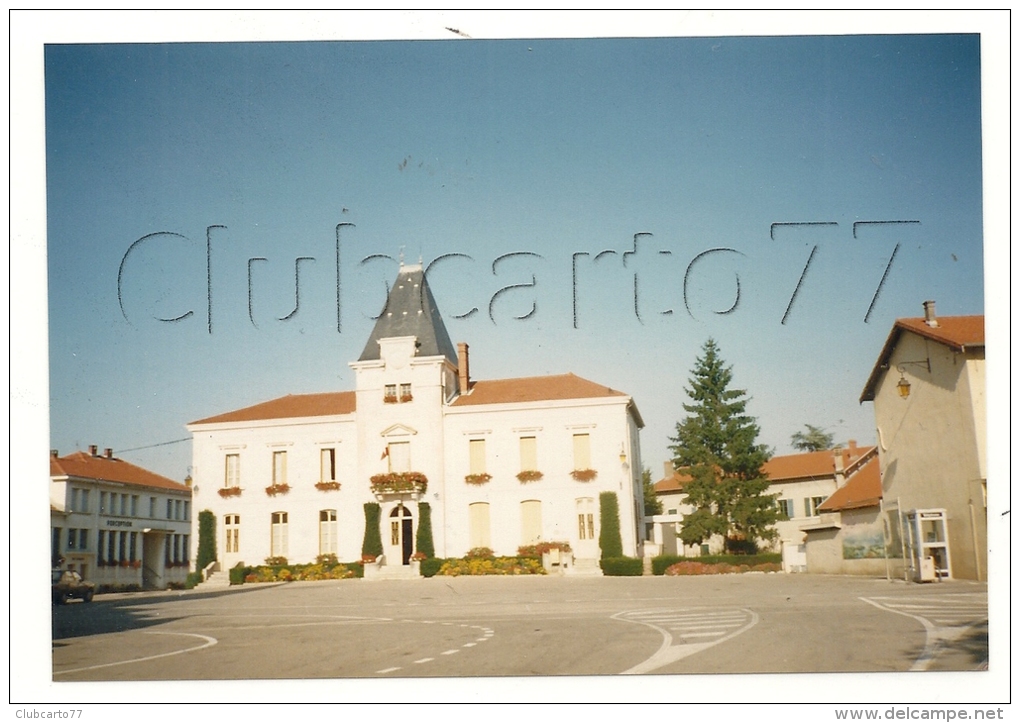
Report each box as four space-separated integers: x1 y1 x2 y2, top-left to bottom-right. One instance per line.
45 35 984 479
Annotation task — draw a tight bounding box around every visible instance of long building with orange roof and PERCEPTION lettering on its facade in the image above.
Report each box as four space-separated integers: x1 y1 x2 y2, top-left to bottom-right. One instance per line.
50 445 192 589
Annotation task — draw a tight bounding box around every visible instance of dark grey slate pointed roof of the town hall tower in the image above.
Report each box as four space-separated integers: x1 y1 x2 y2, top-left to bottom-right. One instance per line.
358 264 457 366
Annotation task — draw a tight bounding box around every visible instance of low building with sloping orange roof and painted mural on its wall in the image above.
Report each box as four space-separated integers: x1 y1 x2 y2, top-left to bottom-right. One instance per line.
801 455 889 576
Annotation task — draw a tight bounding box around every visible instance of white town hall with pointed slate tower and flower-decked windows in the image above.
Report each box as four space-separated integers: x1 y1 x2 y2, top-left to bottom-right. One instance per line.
187 264 644 572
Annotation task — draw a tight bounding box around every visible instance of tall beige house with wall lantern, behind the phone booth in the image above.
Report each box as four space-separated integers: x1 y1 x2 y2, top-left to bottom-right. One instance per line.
860 301 987 580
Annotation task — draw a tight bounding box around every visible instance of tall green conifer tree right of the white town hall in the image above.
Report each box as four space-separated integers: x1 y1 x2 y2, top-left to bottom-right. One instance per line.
669 339 778 552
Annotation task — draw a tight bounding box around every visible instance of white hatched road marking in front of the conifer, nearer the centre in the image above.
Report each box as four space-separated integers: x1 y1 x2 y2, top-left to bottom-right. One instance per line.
612 608 758 675
